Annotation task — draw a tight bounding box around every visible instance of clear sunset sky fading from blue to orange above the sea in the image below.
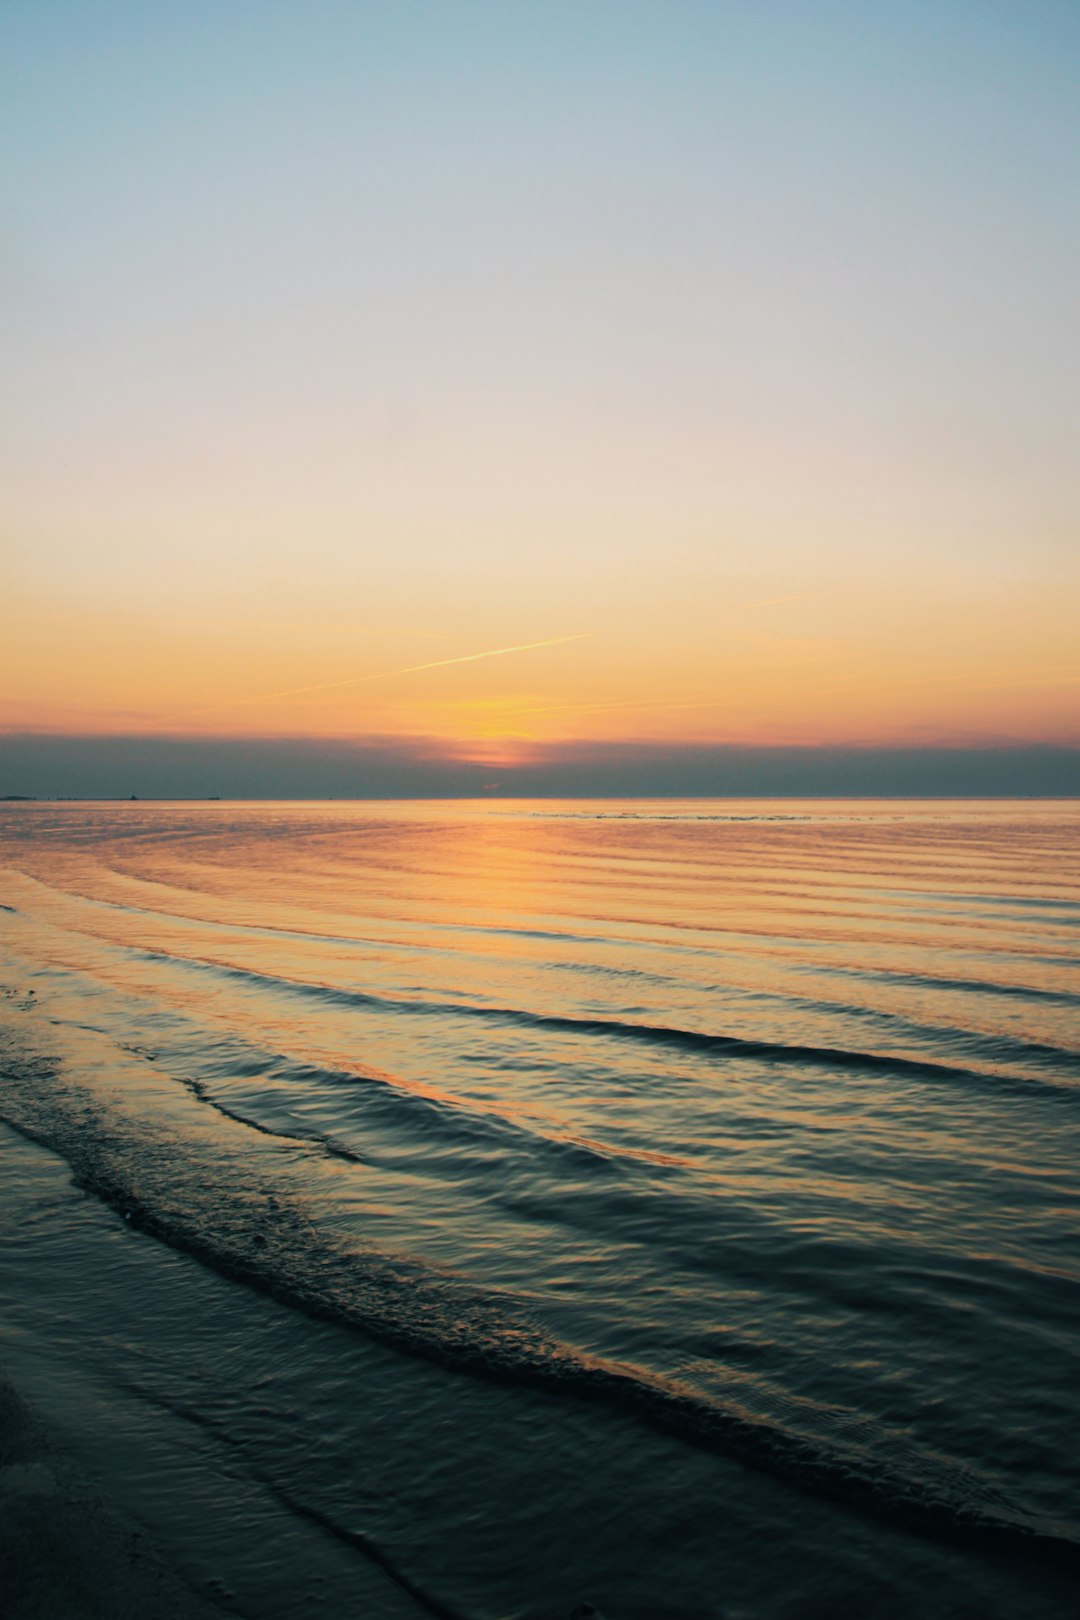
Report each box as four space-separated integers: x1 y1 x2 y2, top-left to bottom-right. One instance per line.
0 0 1080 792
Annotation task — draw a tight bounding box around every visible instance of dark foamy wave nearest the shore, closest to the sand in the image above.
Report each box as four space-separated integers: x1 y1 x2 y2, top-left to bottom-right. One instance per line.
0 1023 1080 1570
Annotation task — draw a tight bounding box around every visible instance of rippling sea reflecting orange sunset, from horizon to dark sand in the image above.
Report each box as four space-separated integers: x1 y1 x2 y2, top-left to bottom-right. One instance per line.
0 800 1080 1620
